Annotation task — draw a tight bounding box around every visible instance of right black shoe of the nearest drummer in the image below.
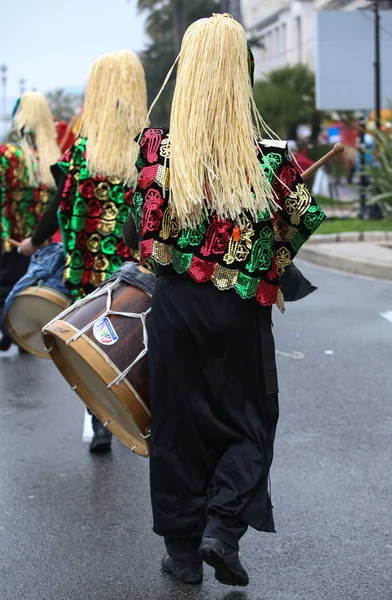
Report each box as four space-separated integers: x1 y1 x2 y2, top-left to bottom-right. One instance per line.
199 537 249 586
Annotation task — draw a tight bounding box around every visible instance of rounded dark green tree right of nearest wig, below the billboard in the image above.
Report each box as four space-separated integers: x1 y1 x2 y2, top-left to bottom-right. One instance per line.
255 65 323 142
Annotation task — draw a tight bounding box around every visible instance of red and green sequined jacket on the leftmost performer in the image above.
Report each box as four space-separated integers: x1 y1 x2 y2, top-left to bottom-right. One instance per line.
0 144 53 252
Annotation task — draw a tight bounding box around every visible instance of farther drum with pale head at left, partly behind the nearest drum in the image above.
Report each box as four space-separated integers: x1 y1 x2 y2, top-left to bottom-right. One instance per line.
4 285 70 359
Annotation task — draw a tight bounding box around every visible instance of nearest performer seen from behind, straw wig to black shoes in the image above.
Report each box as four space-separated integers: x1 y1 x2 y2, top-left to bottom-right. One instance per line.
124 15 324 585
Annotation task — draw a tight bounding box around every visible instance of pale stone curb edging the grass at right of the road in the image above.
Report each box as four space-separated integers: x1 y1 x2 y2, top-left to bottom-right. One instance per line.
298 231 392 280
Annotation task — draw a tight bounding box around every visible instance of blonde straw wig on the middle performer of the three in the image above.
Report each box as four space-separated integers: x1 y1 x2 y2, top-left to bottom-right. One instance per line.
81 50 147 183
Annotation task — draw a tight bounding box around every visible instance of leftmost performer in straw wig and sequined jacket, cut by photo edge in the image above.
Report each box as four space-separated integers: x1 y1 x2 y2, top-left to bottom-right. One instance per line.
0 92 60 350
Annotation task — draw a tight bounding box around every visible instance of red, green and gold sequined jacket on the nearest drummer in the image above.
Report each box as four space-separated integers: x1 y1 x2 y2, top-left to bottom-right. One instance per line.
132 128 325 308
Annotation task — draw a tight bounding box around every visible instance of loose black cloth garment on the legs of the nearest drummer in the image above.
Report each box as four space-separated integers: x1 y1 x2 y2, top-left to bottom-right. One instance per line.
148 267 279 537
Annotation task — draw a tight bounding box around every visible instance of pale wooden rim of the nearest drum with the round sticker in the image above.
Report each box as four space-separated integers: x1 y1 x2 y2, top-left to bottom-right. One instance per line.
42 322 150 457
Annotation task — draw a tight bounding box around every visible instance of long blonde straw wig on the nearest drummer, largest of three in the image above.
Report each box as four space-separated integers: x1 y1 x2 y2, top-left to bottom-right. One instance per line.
170 14 275 227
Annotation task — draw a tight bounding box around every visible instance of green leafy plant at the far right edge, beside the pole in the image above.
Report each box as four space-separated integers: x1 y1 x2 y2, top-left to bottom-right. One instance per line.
364 131 392 214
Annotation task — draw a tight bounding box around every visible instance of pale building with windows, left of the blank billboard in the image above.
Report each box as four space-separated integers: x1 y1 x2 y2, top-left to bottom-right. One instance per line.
242 0 315 79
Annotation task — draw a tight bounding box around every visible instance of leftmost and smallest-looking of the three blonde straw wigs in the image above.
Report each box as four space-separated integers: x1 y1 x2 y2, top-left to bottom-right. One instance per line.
13 92 61 188
